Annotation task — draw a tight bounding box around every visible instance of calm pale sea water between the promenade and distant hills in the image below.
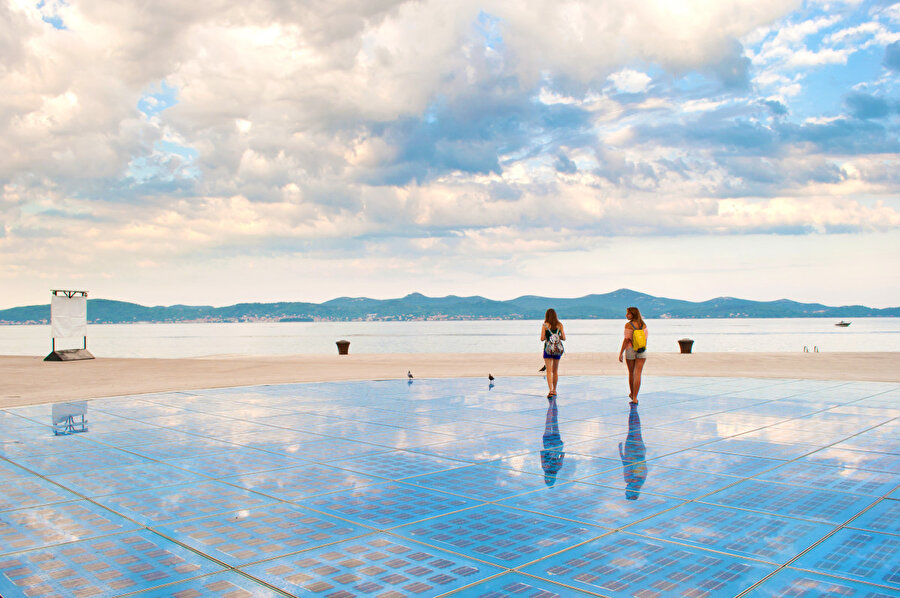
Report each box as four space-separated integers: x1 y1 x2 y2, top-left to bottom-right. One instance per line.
0 318 900 357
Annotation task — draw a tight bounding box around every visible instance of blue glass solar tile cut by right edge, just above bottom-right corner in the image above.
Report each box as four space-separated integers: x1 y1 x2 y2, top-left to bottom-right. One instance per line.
791 528 900 591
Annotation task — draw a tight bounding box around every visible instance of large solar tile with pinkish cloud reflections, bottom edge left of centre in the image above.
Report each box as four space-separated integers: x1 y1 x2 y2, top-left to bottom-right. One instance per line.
244 534 503 598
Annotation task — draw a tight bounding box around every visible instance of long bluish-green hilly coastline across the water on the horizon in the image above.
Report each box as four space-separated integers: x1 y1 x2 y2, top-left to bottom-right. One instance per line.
0 289 900 324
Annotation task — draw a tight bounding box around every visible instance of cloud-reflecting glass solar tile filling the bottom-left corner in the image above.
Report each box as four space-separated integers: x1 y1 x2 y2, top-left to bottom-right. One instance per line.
0 530 222 598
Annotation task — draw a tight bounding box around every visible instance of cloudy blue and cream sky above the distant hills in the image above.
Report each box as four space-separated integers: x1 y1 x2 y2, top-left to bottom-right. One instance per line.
0 0 900 308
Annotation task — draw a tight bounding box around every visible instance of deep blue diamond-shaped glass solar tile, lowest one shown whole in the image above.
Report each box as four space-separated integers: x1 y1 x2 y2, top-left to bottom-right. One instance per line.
391 505 607 568
